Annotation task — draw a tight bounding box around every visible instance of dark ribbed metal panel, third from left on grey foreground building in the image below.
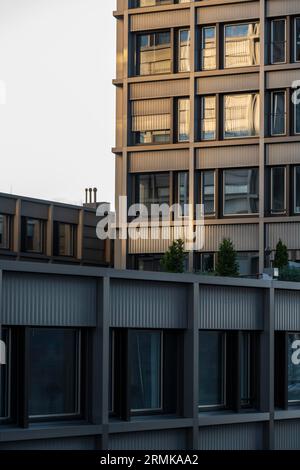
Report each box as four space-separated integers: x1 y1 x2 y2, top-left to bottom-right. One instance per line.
199 286 264 330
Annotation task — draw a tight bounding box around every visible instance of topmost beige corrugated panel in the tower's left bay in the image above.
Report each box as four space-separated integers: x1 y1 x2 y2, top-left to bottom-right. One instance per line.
130 9 190 31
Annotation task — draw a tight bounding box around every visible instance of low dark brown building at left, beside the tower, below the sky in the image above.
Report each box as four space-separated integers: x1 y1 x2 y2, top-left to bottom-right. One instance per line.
0 193 113 267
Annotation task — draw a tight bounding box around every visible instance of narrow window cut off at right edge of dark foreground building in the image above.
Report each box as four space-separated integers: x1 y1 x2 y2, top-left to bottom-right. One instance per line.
287 333 300 403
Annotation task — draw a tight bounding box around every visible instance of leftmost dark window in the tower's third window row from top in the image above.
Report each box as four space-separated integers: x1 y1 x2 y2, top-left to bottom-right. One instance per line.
137 173 170 212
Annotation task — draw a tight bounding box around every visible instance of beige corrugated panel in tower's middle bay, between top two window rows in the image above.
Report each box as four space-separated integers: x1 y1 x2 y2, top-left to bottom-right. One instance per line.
197 73 259 95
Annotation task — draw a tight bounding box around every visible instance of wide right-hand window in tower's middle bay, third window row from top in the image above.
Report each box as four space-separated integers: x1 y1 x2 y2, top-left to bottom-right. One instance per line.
223 168 259 215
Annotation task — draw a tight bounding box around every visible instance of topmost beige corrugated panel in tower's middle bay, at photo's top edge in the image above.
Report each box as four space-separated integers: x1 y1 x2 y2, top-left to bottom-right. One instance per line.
197 1 259 24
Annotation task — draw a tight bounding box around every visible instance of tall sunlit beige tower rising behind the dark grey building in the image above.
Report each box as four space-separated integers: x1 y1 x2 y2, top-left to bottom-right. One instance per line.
113 0 300 274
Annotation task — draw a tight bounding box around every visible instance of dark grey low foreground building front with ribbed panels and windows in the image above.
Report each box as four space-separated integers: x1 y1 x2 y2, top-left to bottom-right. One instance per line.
0 261 300 451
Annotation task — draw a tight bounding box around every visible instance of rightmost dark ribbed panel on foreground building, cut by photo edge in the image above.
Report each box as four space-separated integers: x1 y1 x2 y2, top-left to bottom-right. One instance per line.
275 289 300 331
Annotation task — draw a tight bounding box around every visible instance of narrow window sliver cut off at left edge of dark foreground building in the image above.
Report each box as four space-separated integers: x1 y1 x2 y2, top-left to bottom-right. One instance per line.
0 328 10 420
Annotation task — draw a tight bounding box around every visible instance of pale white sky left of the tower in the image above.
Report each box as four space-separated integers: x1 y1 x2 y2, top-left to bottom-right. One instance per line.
0 0 115 204
